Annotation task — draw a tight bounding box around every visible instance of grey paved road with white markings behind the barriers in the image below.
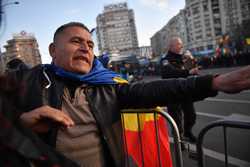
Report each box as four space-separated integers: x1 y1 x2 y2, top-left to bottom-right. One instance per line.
144 68 250 167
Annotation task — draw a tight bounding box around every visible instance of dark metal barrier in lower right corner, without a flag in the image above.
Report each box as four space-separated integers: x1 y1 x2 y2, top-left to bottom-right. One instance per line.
197 115 250 167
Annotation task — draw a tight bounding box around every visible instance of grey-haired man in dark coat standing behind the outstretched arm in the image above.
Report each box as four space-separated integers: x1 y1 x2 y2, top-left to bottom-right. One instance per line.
161 37 198 148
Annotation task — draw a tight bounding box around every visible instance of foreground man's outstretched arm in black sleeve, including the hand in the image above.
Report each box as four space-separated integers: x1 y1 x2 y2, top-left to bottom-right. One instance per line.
119 66 250 108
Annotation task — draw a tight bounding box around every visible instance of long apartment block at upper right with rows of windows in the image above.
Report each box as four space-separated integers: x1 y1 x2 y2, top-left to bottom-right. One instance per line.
151 0 250 55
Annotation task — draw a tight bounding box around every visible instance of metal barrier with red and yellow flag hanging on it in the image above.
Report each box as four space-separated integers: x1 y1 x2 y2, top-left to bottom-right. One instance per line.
121 107 183 167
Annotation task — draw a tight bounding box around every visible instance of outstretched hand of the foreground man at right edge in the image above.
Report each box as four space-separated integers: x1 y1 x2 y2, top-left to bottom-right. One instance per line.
212 66 250 93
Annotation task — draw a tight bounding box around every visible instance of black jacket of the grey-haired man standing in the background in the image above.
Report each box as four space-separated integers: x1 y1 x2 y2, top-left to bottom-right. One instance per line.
161 51 190 78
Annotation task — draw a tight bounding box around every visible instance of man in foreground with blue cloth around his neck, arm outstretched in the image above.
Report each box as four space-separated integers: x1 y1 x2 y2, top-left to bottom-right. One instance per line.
0 22 250 167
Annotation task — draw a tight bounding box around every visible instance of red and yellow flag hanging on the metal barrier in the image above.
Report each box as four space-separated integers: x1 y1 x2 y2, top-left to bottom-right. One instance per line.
122 108 172 167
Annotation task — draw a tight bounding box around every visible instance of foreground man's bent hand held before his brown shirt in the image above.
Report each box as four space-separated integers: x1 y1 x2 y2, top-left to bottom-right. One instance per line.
20 106 74 133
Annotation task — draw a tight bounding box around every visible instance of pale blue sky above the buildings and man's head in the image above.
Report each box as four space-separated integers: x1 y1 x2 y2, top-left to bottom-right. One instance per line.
0 0 185 63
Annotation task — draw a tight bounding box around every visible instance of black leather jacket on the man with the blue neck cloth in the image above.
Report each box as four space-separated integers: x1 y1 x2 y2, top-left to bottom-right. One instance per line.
5 66 217 167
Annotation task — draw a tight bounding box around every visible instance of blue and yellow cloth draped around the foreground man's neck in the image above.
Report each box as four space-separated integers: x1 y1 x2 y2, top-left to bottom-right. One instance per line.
44 58 127 85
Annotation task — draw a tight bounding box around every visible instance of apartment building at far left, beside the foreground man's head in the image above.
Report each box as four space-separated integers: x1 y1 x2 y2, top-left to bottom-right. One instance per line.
3 31 42 67
